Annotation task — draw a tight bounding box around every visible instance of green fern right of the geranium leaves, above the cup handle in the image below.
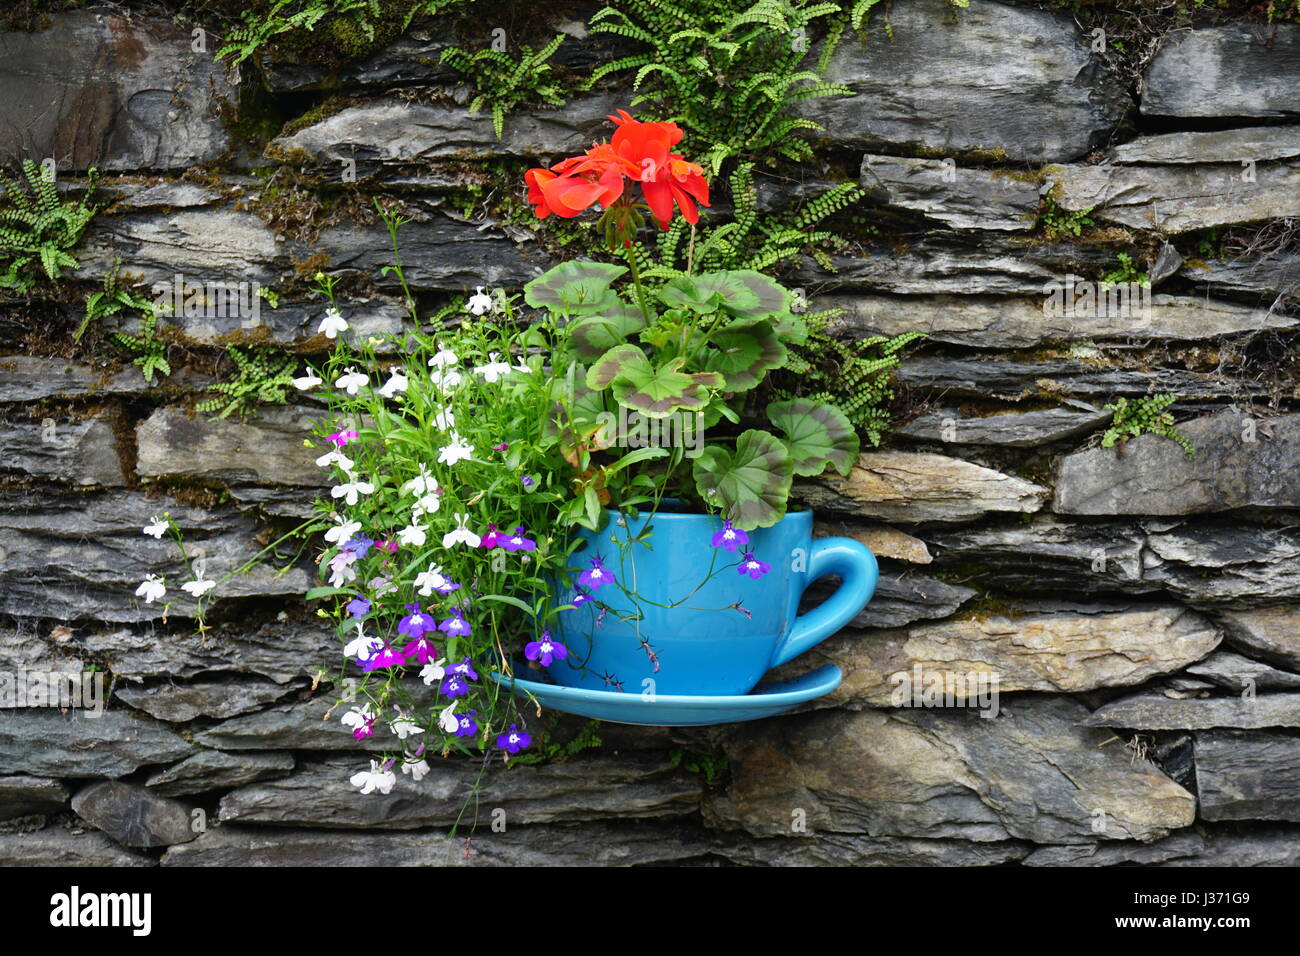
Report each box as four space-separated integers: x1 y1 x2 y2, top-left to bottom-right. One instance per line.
776 325 924 445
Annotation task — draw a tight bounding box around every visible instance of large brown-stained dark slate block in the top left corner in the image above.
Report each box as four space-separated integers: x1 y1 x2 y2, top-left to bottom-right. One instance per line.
0 10 233 170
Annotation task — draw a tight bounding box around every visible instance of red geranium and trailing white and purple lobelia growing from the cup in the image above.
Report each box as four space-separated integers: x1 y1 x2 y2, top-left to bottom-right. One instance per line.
129 112 858 816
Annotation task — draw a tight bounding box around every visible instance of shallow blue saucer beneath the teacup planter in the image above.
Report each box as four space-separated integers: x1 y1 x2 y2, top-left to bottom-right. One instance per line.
491 663 844 727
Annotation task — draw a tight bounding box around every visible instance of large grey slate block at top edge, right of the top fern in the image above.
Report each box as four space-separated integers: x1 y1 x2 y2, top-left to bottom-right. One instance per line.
798 0 1131 161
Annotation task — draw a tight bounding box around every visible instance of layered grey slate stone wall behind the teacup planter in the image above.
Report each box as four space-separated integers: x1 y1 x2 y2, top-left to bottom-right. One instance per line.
0 0 1300 866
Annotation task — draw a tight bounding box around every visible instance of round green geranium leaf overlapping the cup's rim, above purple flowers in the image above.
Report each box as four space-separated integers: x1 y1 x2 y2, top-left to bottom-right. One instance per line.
692 428 794 531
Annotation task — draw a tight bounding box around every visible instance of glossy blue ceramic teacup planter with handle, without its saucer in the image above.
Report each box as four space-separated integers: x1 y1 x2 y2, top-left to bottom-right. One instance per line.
547 511 879 697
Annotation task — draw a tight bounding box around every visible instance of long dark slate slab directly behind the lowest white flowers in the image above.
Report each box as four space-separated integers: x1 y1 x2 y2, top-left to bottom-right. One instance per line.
221 753 701 830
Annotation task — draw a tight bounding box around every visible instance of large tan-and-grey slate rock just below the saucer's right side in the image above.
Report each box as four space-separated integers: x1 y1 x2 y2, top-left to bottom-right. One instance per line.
706 697 1196 844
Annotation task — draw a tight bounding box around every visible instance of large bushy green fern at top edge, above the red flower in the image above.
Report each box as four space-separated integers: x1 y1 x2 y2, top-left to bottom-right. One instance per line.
589 0 852 176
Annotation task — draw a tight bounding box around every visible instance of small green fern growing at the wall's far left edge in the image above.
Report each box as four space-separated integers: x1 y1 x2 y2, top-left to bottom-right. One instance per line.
0 160 96 293
